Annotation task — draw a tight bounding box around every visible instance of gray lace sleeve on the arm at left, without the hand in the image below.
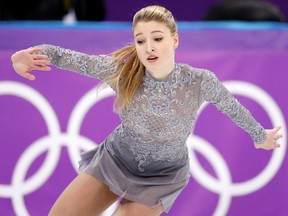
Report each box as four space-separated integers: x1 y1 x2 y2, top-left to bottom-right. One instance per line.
37 44 115 80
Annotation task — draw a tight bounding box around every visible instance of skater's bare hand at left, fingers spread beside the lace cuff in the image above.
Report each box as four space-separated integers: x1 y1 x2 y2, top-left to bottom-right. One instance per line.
11 47 51 80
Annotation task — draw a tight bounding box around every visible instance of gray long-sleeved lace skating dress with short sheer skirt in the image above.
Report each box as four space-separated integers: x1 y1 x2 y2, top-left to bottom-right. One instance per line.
37 45 266 212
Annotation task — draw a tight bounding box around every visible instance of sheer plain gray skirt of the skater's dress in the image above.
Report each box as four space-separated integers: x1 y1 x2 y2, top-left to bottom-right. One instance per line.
79 142 189 213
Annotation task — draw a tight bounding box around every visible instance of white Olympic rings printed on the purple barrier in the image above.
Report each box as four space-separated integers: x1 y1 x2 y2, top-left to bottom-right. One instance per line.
0 81 287 216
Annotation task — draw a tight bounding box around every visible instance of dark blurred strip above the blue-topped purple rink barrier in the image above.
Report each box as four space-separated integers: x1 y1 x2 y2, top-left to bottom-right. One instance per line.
0 0 288 21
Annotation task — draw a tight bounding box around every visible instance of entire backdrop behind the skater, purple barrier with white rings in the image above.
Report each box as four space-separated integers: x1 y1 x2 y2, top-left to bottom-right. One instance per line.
0 0 288 216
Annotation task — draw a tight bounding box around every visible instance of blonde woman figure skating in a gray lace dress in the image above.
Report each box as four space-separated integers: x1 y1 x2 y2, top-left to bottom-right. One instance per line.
11 5 282 216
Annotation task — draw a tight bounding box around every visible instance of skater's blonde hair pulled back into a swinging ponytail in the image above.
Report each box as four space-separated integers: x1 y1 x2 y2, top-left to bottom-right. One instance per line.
106 5 177 111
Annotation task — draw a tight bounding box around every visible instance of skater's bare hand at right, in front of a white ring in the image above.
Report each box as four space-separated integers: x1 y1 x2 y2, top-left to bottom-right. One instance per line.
254 126 283 150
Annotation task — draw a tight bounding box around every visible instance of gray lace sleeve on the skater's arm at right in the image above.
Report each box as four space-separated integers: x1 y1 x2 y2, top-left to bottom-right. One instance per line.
201 71 267 144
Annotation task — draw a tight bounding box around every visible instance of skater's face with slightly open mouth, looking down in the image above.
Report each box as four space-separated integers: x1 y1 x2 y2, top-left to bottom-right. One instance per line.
134 21 178 79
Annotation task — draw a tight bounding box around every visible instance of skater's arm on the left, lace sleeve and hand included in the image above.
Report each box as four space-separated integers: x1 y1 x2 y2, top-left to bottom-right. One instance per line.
11 44 115 80
